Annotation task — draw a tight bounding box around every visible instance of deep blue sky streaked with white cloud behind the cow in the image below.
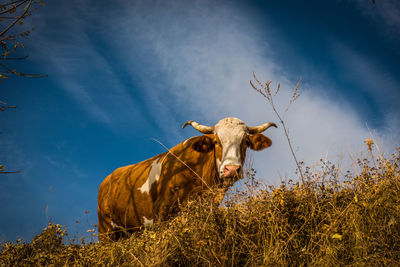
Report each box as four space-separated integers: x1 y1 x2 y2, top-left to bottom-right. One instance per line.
0 0 400 243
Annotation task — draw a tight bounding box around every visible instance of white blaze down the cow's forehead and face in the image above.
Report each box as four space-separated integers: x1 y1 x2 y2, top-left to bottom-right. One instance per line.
215 118 247 175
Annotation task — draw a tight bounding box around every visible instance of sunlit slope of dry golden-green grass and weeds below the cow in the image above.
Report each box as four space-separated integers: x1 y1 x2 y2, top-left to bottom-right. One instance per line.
0 147 400 266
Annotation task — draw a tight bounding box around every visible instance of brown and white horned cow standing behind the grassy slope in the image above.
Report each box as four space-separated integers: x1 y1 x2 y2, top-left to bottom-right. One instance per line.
97 117 277 241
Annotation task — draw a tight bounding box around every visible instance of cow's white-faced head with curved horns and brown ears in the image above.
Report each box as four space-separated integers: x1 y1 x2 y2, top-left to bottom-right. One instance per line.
182 118 277 185
